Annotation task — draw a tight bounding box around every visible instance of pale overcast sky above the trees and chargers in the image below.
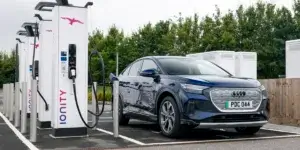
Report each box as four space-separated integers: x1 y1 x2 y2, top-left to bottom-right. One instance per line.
0 0 293 51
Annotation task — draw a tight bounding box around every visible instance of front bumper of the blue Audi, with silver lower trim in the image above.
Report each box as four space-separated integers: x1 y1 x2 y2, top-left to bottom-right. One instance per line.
181 89 269 128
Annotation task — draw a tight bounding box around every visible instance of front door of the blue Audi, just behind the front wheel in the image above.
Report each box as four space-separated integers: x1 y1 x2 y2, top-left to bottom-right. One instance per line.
139 59 160 115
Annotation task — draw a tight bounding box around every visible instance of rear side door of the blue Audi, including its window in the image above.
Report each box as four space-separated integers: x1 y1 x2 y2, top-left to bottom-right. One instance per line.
127 60 143 112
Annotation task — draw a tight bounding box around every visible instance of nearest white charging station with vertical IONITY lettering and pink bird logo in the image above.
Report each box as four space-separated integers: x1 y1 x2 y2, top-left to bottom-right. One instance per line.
36 0 92 138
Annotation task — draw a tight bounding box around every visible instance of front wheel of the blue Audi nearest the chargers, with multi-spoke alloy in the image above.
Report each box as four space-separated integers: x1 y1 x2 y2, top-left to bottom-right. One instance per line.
158 96 183 138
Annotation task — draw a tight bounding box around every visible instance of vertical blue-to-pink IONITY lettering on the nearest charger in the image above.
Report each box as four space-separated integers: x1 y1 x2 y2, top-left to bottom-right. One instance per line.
59 90 67 124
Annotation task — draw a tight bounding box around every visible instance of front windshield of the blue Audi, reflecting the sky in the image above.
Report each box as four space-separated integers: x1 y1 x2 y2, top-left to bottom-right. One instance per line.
158 58 231 76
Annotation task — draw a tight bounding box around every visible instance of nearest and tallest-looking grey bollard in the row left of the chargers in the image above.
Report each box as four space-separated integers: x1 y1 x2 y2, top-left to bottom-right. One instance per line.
30 80 37 142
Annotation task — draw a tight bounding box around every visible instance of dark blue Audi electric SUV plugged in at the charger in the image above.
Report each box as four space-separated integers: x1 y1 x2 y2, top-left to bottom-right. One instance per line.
118 56 268 137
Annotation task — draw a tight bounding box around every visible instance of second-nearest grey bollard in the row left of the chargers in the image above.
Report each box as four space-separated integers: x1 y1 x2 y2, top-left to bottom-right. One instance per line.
21 82 27 133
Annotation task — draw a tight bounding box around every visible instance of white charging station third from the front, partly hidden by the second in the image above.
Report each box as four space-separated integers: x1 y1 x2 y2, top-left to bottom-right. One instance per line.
22 22 39 116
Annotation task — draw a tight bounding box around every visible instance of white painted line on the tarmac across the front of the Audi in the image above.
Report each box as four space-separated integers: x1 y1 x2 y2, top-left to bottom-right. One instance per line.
146 135 300 146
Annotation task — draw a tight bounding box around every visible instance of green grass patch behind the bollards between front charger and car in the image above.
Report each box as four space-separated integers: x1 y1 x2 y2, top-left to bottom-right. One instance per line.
88 86 112 101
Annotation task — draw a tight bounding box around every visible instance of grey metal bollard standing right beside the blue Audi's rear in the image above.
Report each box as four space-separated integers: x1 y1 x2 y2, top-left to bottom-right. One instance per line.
113 81 119 138
